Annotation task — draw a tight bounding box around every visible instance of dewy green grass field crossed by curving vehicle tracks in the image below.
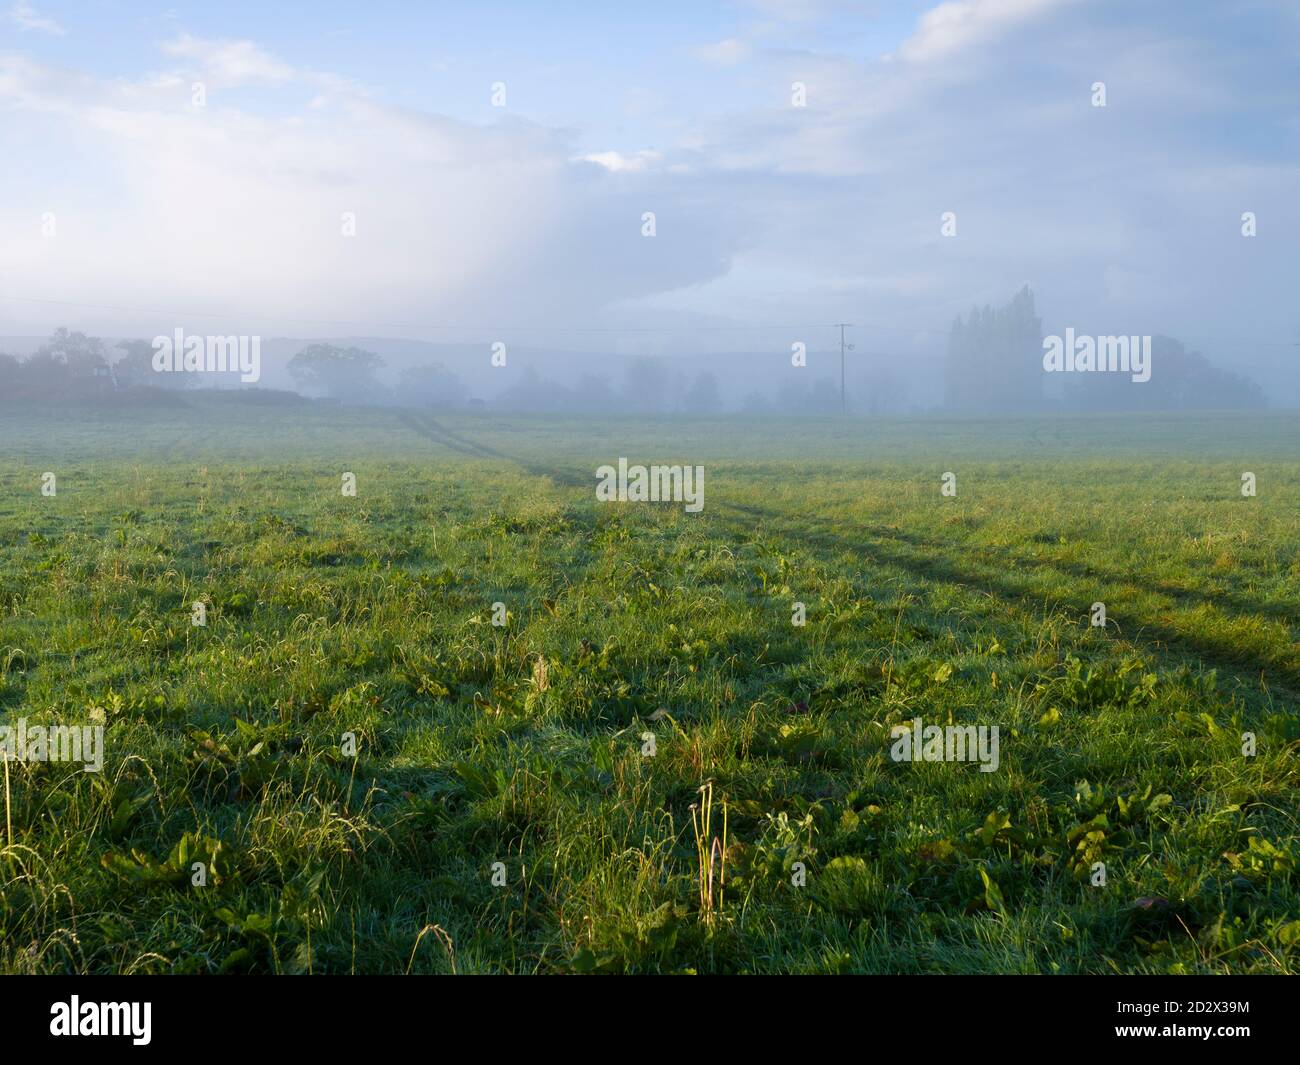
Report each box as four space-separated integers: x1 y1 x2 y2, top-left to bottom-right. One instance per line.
0 402 1300 973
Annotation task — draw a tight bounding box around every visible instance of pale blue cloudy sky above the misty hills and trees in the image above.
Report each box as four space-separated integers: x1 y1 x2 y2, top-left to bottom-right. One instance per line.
0 0 1300 402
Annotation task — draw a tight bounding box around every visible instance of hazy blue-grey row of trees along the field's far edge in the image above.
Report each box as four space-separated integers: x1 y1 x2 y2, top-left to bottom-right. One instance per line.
0 312 1266 416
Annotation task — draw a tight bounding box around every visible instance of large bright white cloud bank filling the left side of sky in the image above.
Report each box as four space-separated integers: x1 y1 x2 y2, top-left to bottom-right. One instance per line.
0 39 735 332
